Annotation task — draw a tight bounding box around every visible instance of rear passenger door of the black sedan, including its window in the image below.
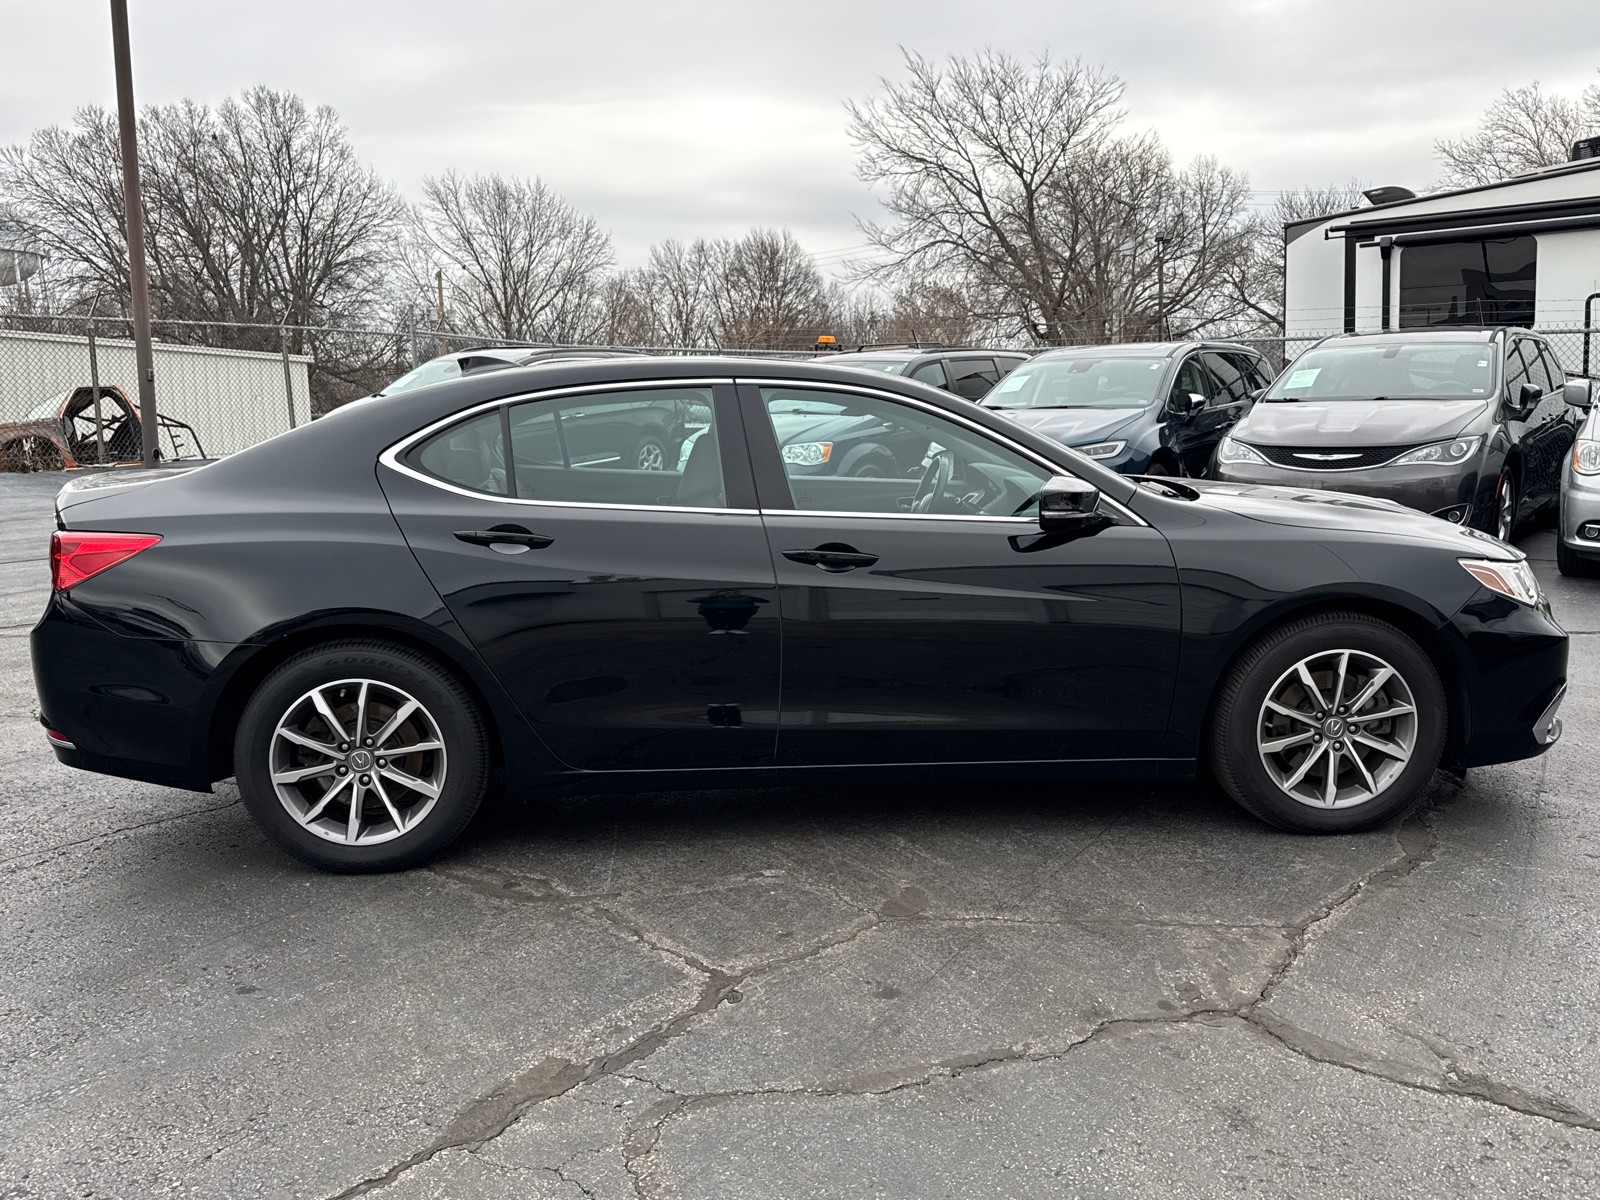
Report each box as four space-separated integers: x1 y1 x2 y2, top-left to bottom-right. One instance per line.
379 382 779 771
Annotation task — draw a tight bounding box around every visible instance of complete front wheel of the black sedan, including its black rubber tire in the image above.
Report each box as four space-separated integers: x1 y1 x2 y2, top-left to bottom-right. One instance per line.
1208 613 1448 834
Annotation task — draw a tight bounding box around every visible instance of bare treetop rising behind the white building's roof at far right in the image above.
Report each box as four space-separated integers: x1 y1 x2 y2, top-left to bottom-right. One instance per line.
1434 82 1600 187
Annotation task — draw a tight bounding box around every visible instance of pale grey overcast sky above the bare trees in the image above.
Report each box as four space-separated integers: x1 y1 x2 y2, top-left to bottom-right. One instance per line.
0 0 1600 272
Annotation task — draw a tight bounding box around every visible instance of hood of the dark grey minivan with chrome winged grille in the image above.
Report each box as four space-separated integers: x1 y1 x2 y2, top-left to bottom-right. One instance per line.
1234 397 1490 446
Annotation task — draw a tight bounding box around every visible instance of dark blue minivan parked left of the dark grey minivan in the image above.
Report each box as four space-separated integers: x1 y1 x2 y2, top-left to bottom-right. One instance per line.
984 342 1272 477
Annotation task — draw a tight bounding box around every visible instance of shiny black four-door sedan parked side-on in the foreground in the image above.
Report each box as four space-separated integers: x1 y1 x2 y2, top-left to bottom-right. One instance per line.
32 358 1566 870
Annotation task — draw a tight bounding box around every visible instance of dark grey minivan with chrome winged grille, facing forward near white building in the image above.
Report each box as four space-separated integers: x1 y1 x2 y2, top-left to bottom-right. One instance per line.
1216 328 1579 541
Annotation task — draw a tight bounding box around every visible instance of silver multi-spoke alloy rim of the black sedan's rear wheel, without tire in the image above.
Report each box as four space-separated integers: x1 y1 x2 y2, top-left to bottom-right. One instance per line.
267 678 445 846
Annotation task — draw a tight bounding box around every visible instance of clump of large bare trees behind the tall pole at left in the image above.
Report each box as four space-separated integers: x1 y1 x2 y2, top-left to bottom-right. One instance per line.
0 88 403 340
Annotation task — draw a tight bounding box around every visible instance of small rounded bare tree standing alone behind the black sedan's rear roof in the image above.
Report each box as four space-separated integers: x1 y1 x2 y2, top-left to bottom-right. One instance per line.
416 171 613 342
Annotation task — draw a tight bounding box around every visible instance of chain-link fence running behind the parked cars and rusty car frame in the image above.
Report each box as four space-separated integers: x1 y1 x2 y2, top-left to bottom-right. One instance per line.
0 314 1600 470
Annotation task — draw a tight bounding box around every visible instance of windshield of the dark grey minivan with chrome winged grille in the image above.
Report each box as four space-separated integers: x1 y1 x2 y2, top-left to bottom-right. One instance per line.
1264 342 1494 400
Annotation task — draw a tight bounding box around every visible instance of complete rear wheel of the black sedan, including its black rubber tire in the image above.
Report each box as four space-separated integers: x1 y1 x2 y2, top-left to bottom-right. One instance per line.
234 638 490 874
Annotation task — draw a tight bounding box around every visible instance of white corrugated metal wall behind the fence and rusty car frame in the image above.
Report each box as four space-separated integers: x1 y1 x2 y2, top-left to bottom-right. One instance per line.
0 330 310 456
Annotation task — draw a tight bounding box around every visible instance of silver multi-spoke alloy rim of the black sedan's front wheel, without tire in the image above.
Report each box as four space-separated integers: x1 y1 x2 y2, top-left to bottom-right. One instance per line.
1256 650 1418 808
